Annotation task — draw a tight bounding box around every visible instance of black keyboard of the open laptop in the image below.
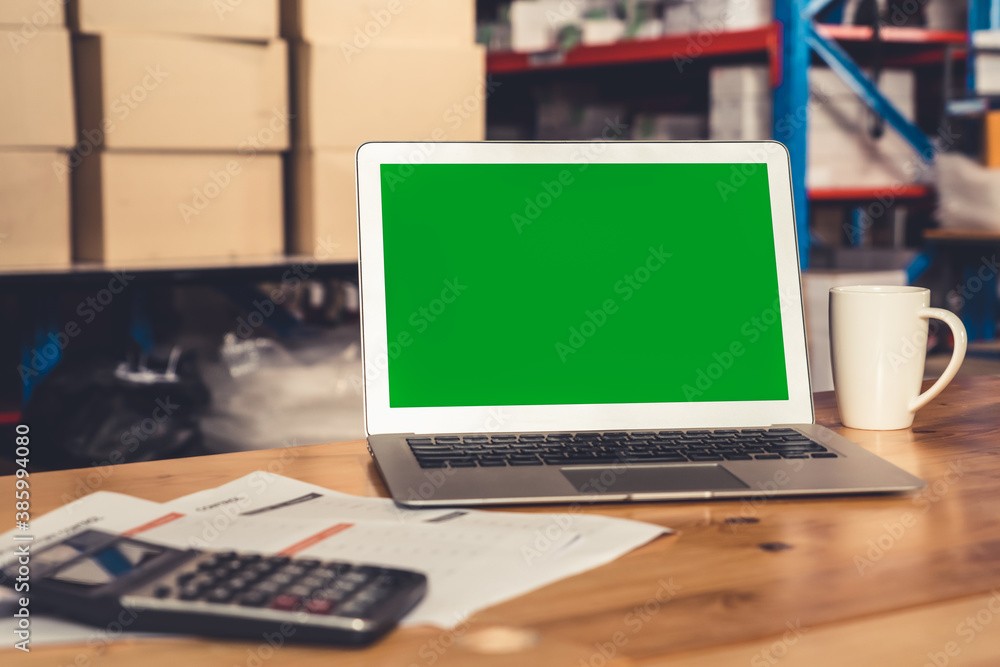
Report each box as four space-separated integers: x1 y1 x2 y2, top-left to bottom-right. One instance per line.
406 428 838 468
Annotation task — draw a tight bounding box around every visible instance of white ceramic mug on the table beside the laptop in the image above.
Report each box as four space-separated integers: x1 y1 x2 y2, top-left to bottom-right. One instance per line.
830 285 968 431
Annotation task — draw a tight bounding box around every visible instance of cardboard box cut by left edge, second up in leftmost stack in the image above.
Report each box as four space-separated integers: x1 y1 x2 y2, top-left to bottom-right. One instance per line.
0 29 76 148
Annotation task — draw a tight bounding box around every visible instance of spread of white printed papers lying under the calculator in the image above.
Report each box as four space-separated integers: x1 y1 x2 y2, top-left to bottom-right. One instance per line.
0 471 670 643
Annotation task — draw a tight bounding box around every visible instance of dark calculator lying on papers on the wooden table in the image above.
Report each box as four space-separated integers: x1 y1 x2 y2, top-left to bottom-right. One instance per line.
4 530 427 645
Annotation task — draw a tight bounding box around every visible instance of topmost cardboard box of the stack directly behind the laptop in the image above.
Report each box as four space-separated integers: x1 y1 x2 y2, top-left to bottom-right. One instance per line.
282 0 476 47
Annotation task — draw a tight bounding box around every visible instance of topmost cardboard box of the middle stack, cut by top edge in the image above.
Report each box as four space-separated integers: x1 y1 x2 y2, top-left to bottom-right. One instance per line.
69 0 278 41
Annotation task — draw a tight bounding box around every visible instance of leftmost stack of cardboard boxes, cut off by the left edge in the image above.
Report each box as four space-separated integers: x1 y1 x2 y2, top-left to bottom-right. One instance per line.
0 8 74 269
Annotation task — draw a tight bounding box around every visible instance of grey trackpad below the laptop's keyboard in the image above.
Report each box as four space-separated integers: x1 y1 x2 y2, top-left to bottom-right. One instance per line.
560 465 750 493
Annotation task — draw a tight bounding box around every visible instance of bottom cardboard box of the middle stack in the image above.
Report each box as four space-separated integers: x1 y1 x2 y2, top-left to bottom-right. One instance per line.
73 152 284 263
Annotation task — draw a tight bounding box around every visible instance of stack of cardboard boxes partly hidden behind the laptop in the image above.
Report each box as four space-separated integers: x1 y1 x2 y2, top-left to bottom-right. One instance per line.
282 0 490 261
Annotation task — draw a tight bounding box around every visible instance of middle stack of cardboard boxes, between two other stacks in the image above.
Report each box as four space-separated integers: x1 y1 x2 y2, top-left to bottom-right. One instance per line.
69 0 291 263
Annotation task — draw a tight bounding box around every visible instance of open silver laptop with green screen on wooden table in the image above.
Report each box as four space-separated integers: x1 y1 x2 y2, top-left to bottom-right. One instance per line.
357 142 924 507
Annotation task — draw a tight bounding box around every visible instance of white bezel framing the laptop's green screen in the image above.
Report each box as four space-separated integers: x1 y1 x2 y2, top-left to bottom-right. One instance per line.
357 141 814 435
